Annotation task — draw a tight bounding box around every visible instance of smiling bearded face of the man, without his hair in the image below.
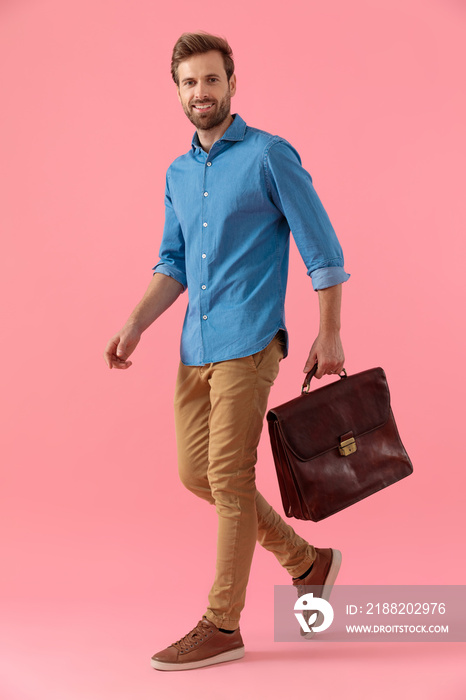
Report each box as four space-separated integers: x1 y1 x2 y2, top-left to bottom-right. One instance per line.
178 51 236 130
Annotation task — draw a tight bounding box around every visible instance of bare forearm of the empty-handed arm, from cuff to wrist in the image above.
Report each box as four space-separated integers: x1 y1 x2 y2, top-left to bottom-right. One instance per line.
125 272 183 333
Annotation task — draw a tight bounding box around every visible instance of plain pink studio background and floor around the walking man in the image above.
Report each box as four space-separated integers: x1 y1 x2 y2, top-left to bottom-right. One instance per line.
0 0 466 700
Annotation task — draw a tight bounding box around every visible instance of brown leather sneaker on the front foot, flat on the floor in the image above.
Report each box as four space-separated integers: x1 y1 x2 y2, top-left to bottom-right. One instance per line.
151 617 244 671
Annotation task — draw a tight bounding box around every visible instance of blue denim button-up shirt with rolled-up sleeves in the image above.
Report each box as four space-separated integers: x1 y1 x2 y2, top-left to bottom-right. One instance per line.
153 114 349 365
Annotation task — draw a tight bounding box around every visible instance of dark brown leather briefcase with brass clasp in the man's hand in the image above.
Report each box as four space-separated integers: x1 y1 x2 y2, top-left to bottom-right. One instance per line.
267 367 413 522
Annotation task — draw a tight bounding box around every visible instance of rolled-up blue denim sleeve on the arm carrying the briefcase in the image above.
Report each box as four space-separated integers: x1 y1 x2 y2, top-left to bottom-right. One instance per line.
264 137 350 291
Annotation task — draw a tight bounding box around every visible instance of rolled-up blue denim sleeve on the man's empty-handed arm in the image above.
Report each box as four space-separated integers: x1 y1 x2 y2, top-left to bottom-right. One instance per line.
152 173 188 291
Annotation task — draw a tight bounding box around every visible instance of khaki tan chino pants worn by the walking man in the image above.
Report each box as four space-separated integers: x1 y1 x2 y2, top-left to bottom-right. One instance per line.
175 331 316 630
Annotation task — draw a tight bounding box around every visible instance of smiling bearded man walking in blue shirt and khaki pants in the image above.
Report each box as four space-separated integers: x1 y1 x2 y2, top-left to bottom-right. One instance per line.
105 34 349 670
